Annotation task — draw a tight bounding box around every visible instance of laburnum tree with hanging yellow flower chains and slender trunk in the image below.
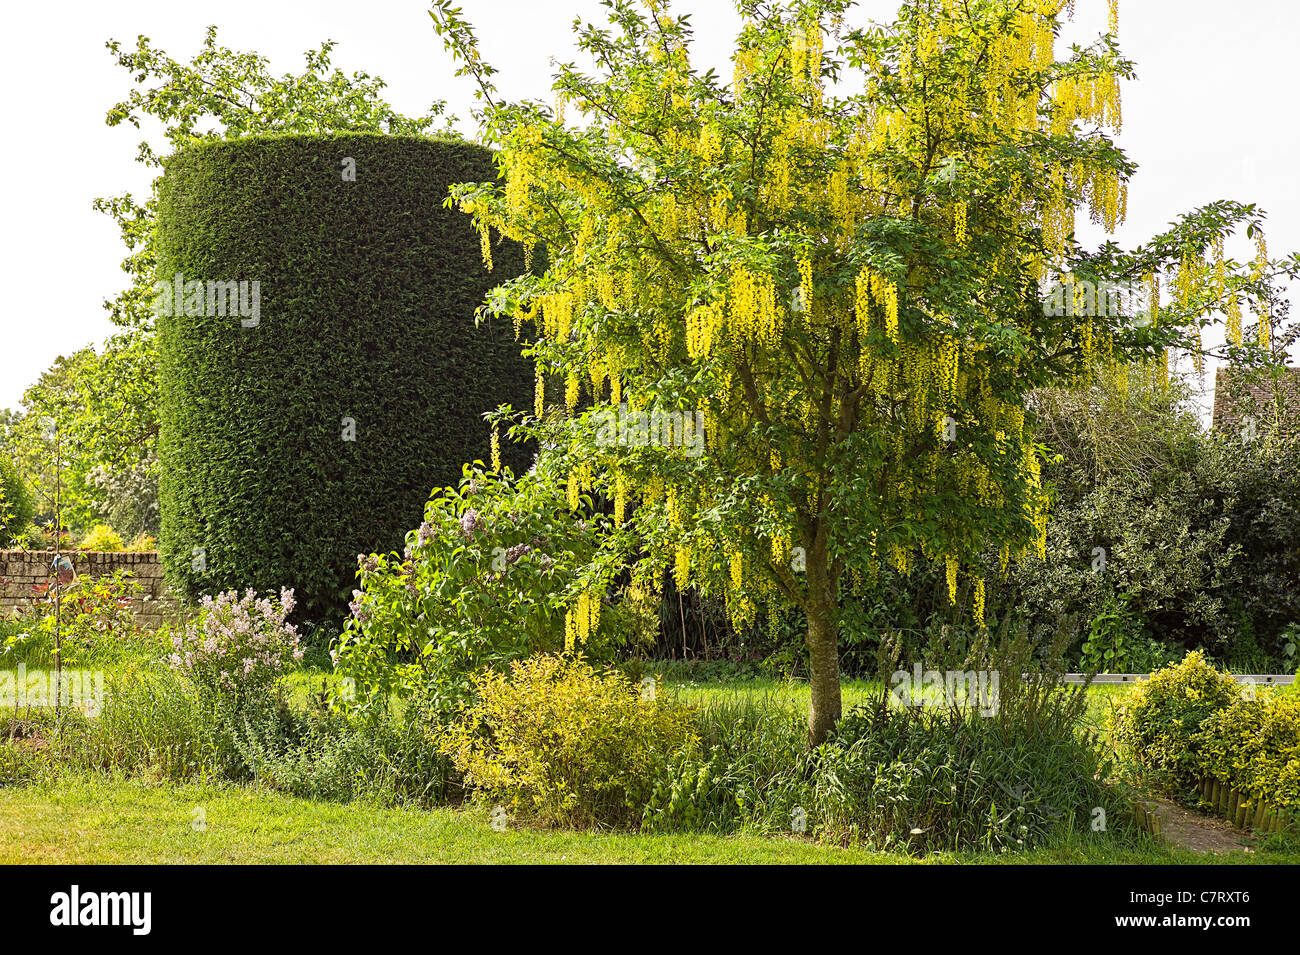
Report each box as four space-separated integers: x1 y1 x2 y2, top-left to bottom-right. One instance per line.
432 0 1297 745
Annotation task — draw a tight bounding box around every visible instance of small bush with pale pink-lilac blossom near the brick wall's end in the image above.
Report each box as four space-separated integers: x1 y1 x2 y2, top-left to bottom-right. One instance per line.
169 589 303 702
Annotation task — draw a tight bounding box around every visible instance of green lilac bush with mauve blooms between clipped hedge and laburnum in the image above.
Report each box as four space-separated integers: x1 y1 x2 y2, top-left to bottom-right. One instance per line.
334 465 631 716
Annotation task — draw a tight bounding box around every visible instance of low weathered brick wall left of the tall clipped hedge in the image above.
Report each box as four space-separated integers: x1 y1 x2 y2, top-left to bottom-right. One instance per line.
0 551 177 629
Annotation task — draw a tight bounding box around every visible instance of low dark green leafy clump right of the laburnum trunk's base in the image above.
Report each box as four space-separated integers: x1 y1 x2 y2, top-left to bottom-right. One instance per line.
814 690 1122 852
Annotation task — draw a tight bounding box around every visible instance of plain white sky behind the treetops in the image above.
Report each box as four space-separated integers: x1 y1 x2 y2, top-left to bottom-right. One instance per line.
0 0 1300 420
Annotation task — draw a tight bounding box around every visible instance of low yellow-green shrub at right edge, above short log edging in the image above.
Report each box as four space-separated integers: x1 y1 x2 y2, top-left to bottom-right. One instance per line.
1191 691 1300 812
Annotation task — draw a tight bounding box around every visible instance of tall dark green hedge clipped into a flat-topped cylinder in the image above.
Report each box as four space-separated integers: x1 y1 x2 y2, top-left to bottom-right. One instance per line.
157 134 533 620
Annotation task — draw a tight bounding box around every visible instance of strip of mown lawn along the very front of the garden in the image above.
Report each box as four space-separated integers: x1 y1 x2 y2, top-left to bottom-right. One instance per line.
0 776 1300 865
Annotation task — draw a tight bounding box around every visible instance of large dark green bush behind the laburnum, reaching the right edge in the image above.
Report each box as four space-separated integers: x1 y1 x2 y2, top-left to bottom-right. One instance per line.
995 420 1300 670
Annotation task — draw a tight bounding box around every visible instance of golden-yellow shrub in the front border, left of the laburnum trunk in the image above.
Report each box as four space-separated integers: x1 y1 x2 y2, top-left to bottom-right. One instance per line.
438 655 699 828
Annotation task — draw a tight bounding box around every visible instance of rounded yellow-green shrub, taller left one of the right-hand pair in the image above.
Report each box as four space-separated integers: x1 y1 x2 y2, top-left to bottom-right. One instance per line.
1110 651 1242 791
